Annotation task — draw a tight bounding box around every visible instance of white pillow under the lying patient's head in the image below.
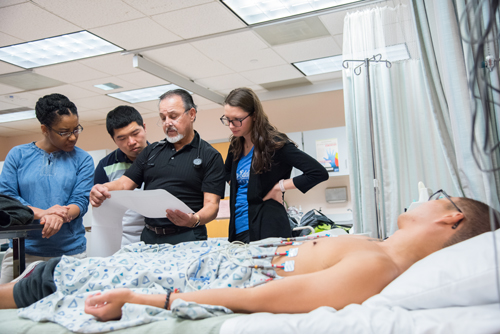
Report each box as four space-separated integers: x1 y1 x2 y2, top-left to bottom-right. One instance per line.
363 229 500 310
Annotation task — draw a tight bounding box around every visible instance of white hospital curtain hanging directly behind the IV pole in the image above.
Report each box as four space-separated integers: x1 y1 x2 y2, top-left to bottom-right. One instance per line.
343 5 461 237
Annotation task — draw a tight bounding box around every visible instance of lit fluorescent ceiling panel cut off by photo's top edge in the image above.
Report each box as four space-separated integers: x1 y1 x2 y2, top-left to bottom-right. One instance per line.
221 0 360 24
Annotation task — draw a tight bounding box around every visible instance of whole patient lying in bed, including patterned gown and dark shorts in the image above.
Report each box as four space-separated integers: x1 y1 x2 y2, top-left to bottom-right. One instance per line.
0 196 500 321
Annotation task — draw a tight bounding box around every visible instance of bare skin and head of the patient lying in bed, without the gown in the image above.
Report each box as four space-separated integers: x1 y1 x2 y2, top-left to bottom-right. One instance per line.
0 196 498 321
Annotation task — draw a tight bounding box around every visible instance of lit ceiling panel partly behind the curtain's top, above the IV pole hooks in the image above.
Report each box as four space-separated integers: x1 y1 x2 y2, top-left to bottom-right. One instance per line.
292 44 410 76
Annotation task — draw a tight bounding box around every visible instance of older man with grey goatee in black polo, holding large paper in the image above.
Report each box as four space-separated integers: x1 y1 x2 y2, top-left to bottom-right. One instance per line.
90 89 224 244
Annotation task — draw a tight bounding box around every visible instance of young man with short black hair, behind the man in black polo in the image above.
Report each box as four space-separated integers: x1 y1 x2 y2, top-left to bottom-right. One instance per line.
94 106 149 247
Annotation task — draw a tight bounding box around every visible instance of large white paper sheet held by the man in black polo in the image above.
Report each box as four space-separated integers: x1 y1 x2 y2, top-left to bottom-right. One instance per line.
87 189 193 256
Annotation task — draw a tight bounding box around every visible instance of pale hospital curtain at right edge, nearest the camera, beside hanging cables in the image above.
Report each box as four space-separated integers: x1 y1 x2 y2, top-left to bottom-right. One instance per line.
412 0 500 206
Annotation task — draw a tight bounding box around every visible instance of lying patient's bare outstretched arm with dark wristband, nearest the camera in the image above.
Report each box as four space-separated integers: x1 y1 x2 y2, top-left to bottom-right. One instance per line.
85 256 398 320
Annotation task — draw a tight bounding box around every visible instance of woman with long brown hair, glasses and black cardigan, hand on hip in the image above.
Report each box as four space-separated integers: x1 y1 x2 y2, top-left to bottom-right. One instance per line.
221 88 328 243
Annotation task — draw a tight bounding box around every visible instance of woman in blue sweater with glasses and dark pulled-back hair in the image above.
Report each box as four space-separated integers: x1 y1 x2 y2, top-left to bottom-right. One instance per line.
0 94 94 283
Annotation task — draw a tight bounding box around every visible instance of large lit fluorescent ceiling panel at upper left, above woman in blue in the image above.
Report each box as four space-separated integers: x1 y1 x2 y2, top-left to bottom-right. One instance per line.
0 31 123 68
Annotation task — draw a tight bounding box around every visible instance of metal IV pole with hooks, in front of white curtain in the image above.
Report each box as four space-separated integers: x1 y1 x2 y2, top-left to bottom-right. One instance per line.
342 54 392 239
